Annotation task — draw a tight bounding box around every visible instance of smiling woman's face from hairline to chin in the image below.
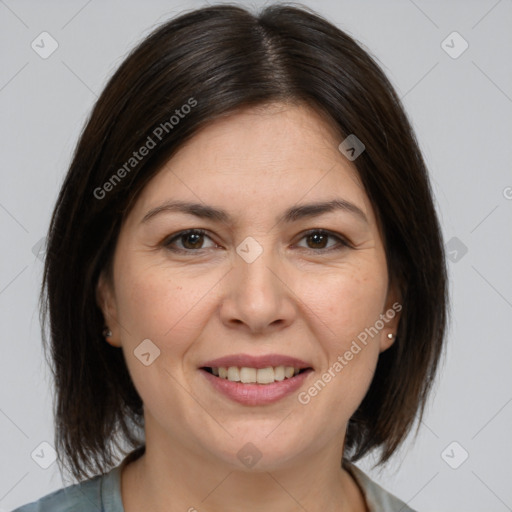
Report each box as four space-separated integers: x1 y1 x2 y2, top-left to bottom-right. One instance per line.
98 104 400 469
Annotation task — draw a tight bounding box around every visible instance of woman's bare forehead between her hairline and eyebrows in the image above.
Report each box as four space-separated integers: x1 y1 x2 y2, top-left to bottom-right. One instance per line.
124 104 371 226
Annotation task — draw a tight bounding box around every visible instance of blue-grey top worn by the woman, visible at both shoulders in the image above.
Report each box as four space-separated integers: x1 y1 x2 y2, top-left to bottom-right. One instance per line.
12 450 415 512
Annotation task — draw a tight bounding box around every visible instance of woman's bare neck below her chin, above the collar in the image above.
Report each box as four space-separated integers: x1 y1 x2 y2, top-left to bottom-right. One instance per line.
121 418 367 512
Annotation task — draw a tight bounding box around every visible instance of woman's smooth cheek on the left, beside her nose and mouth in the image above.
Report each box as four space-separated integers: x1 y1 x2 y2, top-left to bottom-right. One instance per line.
116 262 213 404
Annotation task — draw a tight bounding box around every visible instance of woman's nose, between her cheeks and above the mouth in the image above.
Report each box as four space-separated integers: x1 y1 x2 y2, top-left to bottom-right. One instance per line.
220 242 296 335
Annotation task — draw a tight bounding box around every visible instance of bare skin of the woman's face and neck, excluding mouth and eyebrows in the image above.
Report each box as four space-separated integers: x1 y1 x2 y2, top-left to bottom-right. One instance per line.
98 104 400 512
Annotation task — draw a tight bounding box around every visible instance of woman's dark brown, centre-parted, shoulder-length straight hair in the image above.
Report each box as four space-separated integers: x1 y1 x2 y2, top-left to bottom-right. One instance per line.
40 4 448 480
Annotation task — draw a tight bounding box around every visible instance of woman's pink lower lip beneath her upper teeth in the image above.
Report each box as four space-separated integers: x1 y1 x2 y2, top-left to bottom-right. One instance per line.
200 369 313 405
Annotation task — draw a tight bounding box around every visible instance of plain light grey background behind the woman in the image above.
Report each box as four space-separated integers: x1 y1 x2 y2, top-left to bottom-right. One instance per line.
0 0 512 512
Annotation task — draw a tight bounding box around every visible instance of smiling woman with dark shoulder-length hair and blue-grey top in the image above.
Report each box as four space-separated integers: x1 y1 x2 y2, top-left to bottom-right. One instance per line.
13 5 447 512
